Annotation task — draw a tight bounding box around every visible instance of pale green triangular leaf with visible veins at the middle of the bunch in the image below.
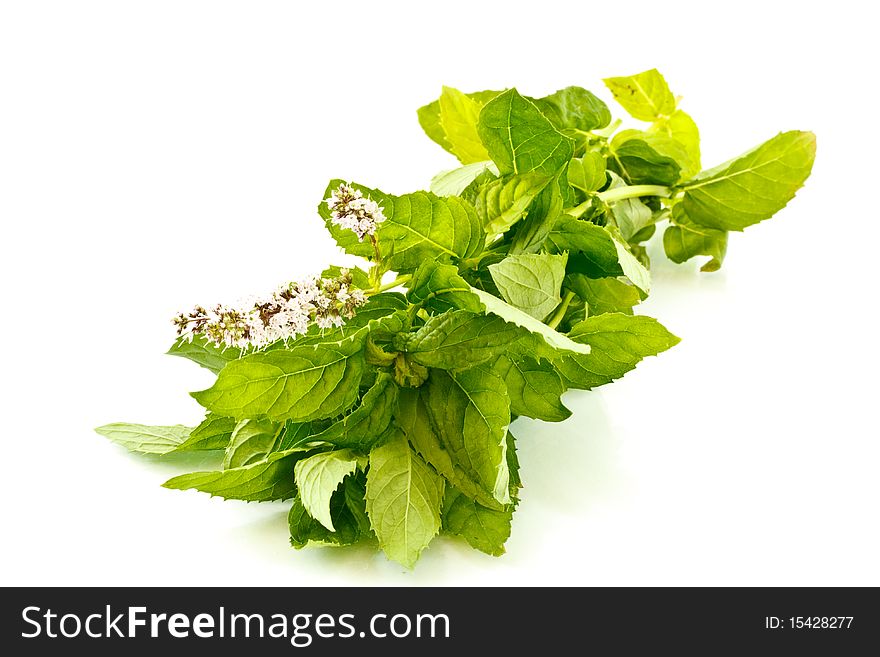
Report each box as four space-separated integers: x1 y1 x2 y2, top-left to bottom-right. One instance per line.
489 253 568 319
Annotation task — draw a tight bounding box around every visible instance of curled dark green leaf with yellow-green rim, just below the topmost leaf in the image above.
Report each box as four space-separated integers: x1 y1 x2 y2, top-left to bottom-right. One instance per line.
609 130 687 185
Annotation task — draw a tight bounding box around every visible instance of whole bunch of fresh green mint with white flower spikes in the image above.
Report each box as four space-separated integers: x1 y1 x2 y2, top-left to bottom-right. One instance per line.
98 70 816 567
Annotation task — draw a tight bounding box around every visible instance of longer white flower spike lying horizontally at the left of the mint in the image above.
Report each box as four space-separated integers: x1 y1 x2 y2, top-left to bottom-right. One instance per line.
173 269 367 349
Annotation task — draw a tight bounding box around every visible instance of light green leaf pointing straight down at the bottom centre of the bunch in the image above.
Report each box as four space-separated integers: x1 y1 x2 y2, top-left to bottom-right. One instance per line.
366 432 444 568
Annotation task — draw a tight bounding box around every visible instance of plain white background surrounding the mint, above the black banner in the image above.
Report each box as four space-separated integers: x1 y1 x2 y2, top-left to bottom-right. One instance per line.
0 0 880 585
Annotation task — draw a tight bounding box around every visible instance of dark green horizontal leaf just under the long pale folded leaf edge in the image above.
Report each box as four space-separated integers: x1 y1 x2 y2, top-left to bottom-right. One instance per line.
404 310 522 370
